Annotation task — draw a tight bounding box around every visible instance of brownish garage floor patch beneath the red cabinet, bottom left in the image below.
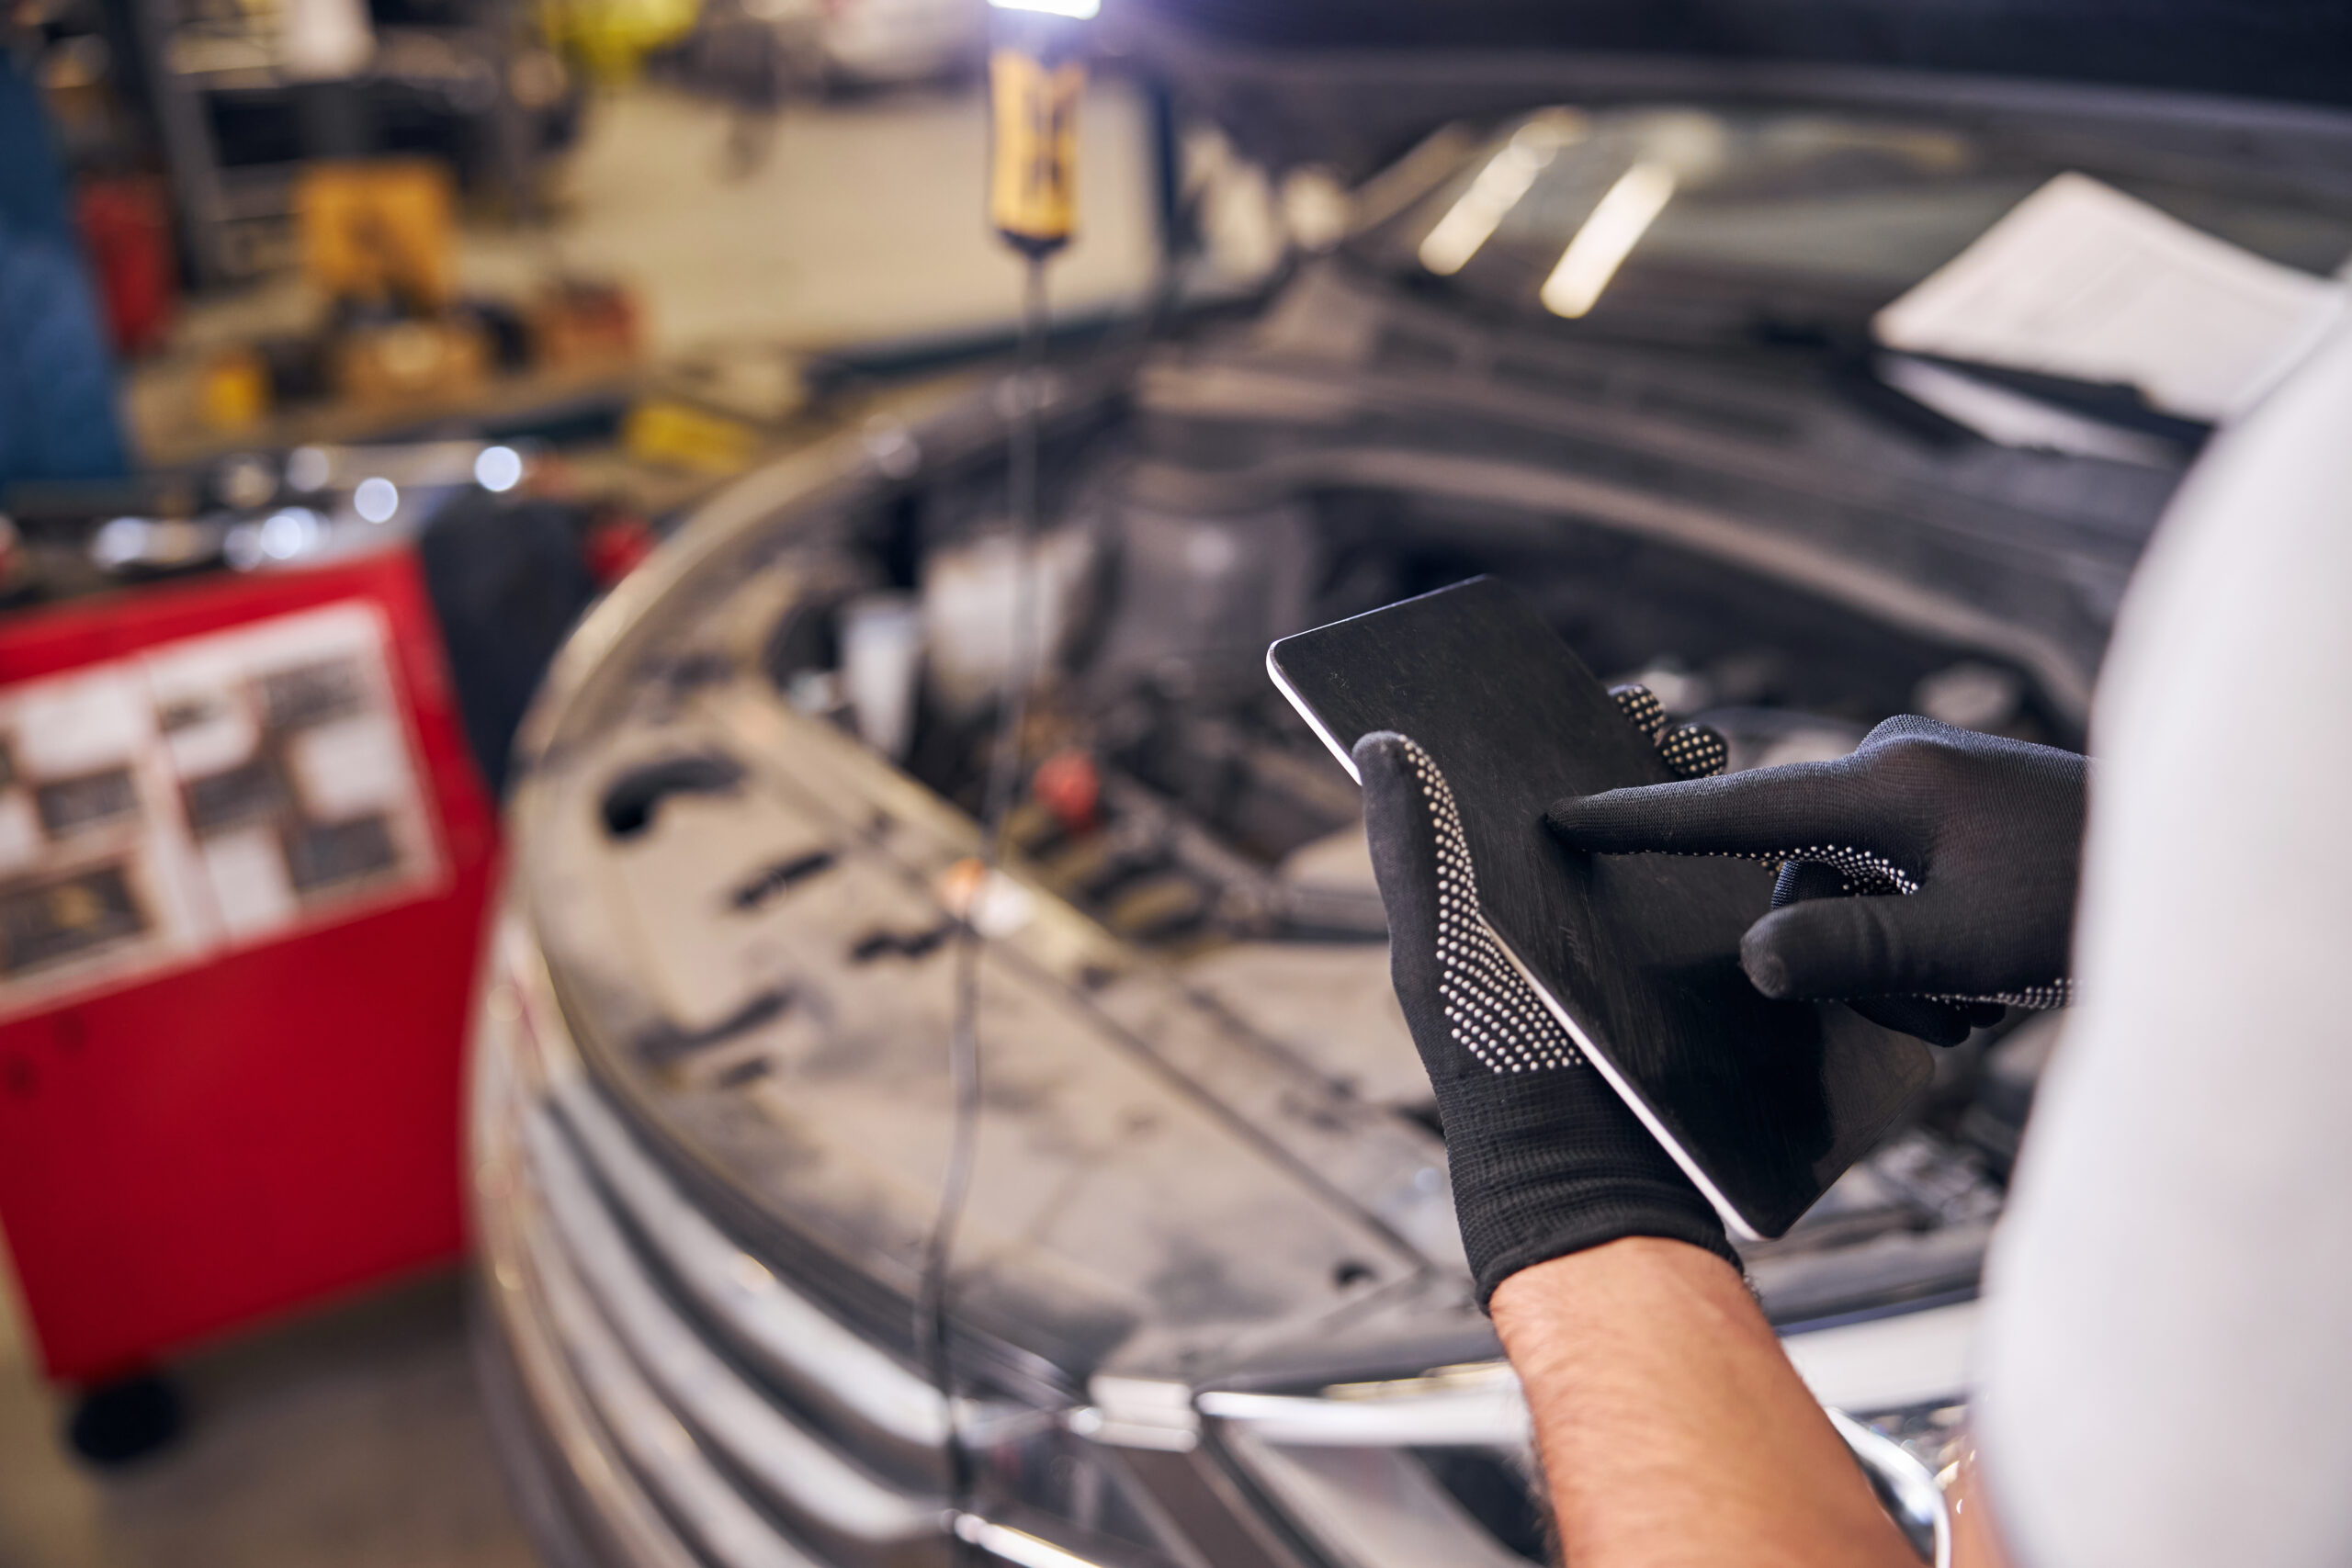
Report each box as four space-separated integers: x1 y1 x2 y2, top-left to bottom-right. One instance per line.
0 1274 534 1568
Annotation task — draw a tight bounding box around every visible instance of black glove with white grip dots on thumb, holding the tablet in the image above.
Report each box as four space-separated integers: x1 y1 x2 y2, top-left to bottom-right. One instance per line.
1355 728 1738 1304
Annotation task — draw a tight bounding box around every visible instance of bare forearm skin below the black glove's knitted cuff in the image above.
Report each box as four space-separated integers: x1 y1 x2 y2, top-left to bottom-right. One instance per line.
1494 1236 1917 1568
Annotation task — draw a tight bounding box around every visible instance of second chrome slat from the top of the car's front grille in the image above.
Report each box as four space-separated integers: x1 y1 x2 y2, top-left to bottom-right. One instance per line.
525 1107 944 1542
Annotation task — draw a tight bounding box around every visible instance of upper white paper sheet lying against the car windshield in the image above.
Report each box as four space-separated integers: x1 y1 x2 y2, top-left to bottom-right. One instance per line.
1872 174 2345 421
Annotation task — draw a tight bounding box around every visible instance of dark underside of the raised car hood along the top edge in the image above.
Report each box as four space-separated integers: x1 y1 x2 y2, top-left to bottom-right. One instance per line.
1103 0 2352 176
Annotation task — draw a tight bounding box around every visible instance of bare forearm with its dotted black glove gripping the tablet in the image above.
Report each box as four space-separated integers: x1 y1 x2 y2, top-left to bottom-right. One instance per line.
1355 733 1915 1568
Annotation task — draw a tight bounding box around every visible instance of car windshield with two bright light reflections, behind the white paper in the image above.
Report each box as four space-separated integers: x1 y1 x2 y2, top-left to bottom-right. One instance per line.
1364 108 2352 339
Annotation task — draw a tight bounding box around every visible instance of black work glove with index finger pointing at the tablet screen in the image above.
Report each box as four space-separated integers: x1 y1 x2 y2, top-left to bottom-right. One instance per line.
1547 717 2088 1043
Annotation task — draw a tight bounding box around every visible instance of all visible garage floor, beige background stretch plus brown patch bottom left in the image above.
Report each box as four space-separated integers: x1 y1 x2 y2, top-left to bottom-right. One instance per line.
0 64 1150 1568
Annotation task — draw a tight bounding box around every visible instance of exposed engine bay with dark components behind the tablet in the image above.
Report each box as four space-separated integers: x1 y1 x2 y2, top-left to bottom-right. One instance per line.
555 285 2154 1354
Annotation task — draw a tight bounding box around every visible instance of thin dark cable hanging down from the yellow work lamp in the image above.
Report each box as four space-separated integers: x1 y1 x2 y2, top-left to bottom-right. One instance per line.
915 256 1046 1561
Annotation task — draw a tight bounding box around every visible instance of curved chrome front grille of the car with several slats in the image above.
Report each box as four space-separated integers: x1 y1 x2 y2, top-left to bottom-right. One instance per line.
473 921 948 1568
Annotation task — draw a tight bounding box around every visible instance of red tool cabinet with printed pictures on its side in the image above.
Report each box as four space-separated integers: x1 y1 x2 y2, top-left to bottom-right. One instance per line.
0 550 496 1384
